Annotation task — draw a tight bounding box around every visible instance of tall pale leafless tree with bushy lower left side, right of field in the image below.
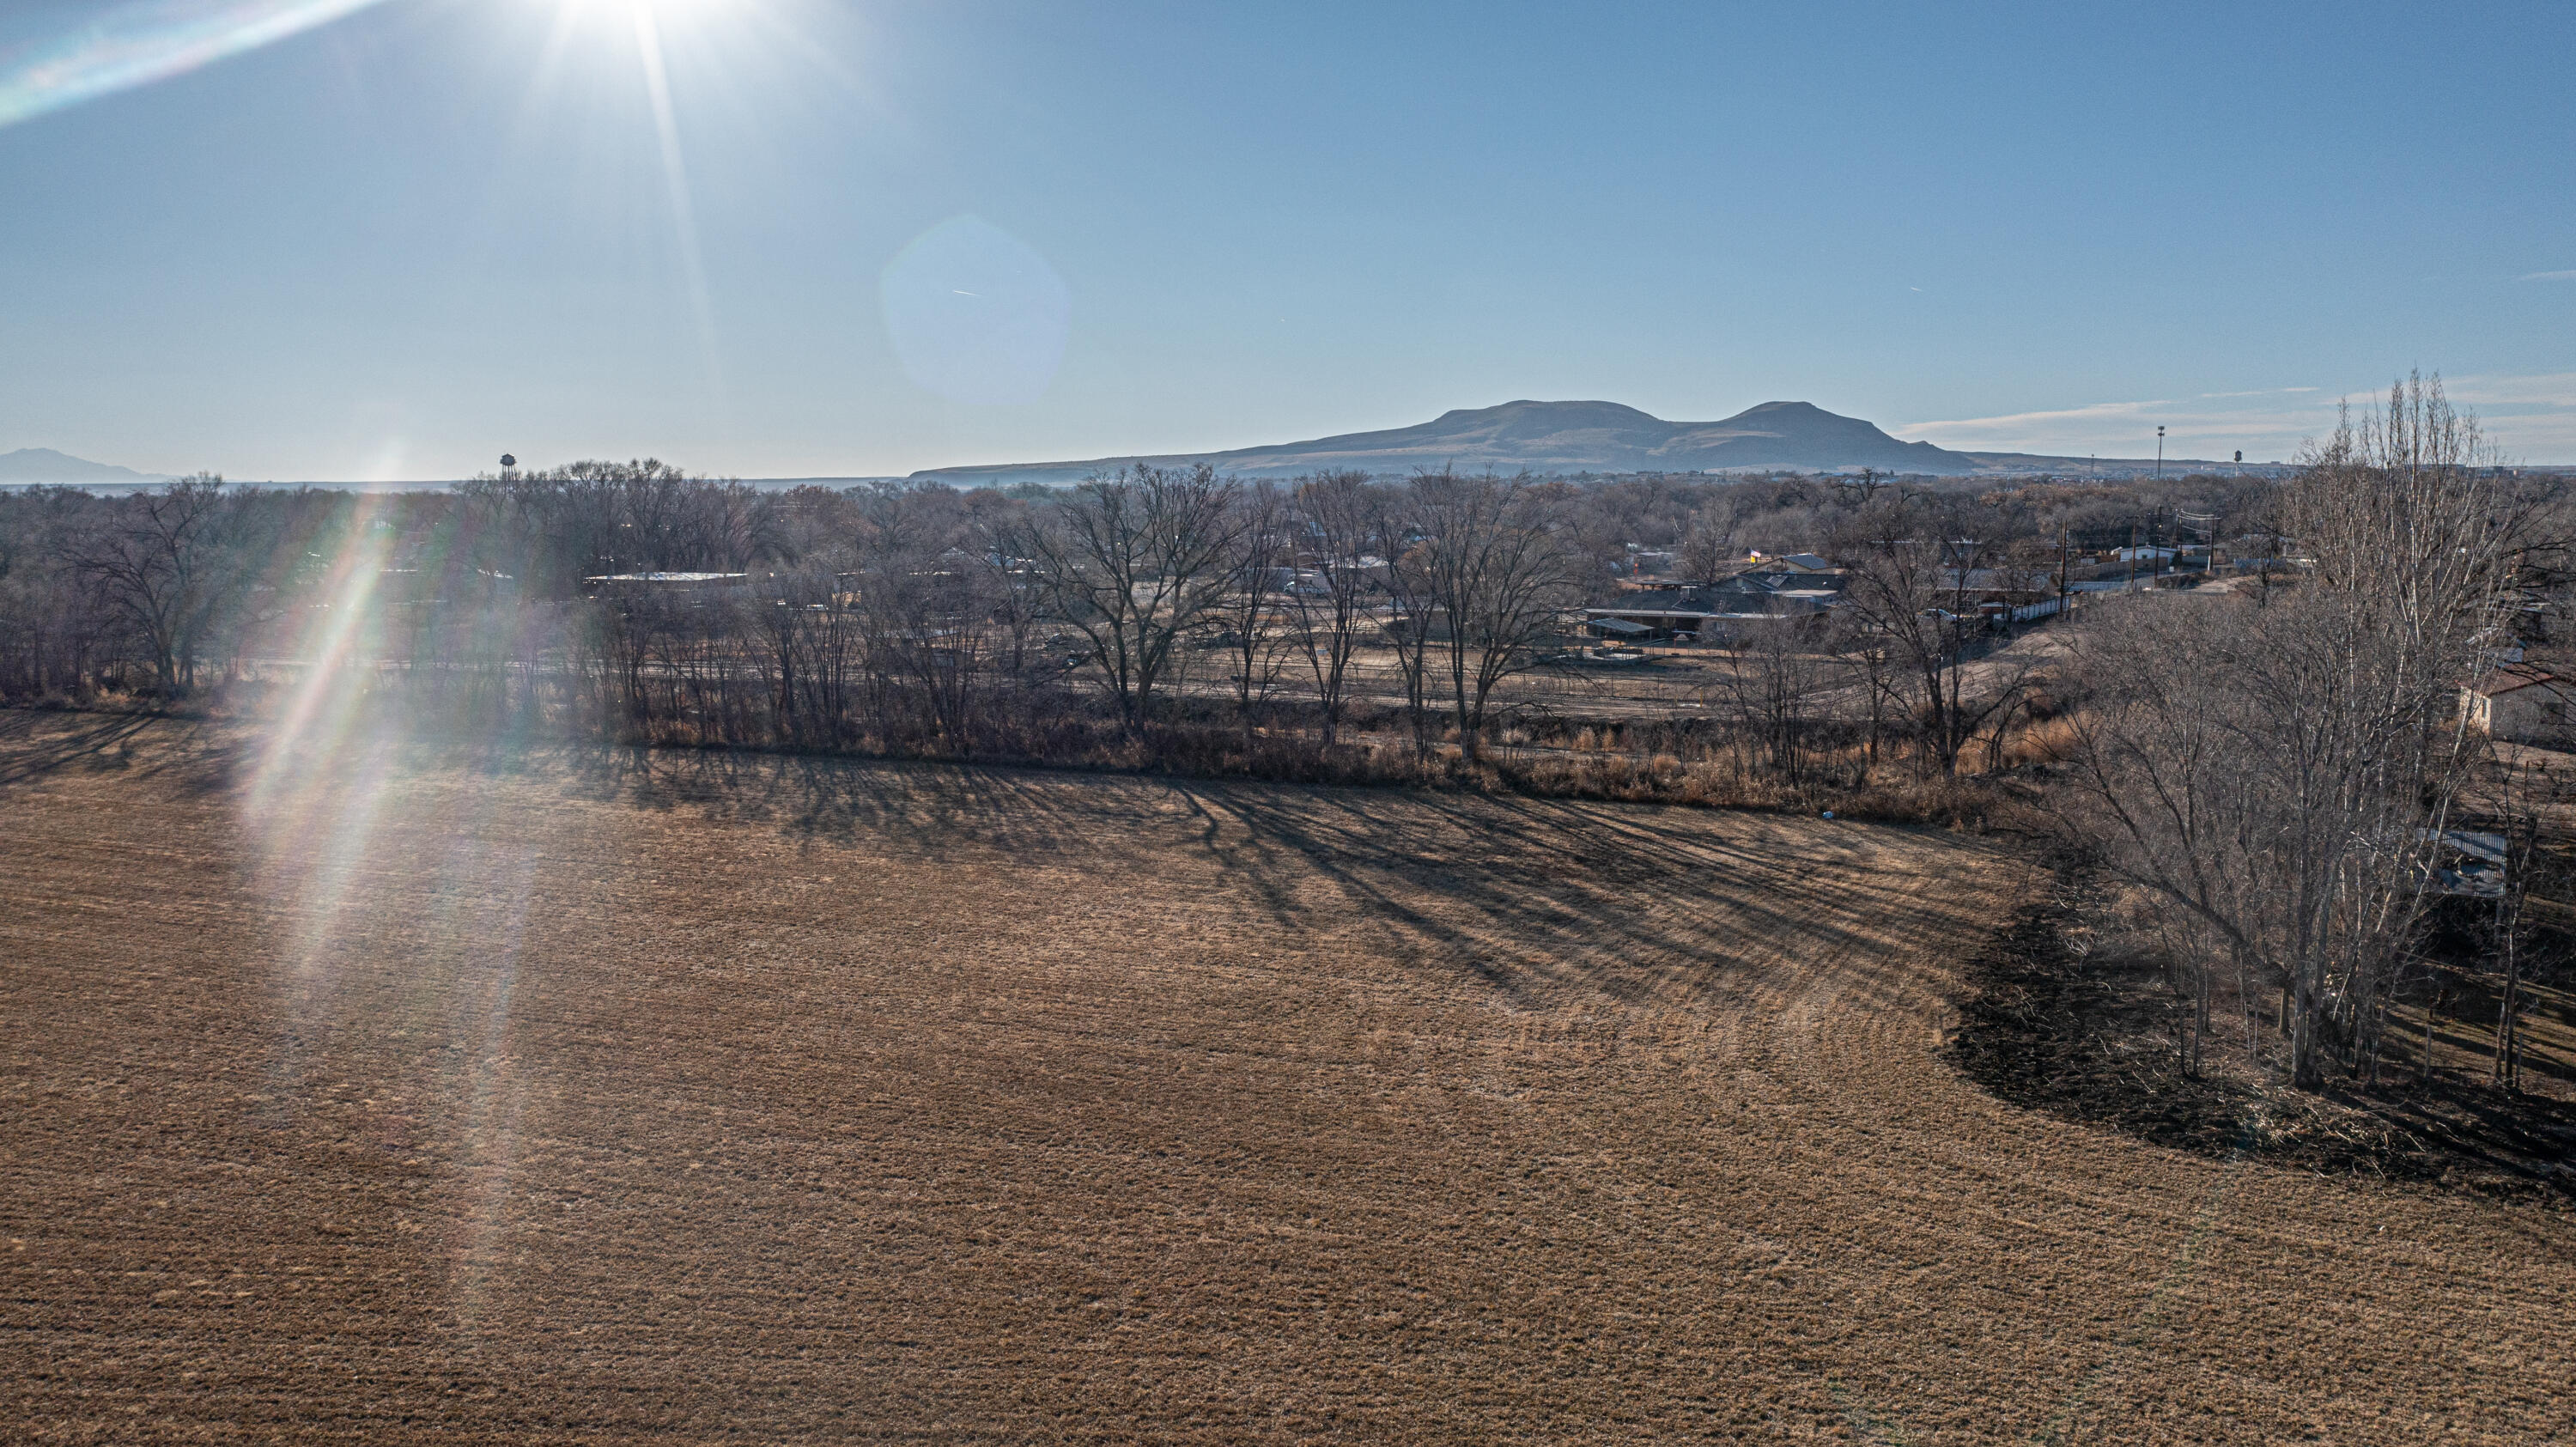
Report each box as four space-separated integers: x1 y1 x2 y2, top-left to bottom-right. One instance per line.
2069 379 2530 1089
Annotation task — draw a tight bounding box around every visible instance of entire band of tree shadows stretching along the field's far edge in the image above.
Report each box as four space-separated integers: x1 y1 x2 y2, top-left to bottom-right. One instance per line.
459 746 1996 1009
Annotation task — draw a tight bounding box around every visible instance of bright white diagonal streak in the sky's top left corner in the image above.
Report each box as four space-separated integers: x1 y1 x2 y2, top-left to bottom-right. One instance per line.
0 0 384 126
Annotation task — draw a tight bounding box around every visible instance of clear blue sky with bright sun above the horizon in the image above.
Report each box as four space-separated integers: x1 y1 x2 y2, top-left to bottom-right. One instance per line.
0 0 2576 479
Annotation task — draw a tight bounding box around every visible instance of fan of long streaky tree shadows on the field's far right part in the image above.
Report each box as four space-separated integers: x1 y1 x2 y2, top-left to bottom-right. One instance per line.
1175 782 2009 1006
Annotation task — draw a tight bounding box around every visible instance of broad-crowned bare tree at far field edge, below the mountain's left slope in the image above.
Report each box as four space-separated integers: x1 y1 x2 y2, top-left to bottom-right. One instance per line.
1012 464 1239 733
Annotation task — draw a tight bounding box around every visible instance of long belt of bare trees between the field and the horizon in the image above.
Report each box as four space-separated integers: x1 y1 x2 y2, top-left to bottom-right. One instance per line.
0 461 2154 785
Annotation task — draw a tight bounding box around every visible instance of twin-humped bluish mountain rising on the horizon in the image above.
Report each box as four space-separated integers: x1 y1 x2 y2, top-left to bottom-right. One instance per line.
912 402 2215 487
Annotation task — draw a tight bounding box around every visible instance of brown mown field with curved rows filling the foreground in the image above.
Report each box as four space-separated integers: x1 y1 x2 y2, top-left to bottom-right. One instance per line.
0 714 2576 1444
